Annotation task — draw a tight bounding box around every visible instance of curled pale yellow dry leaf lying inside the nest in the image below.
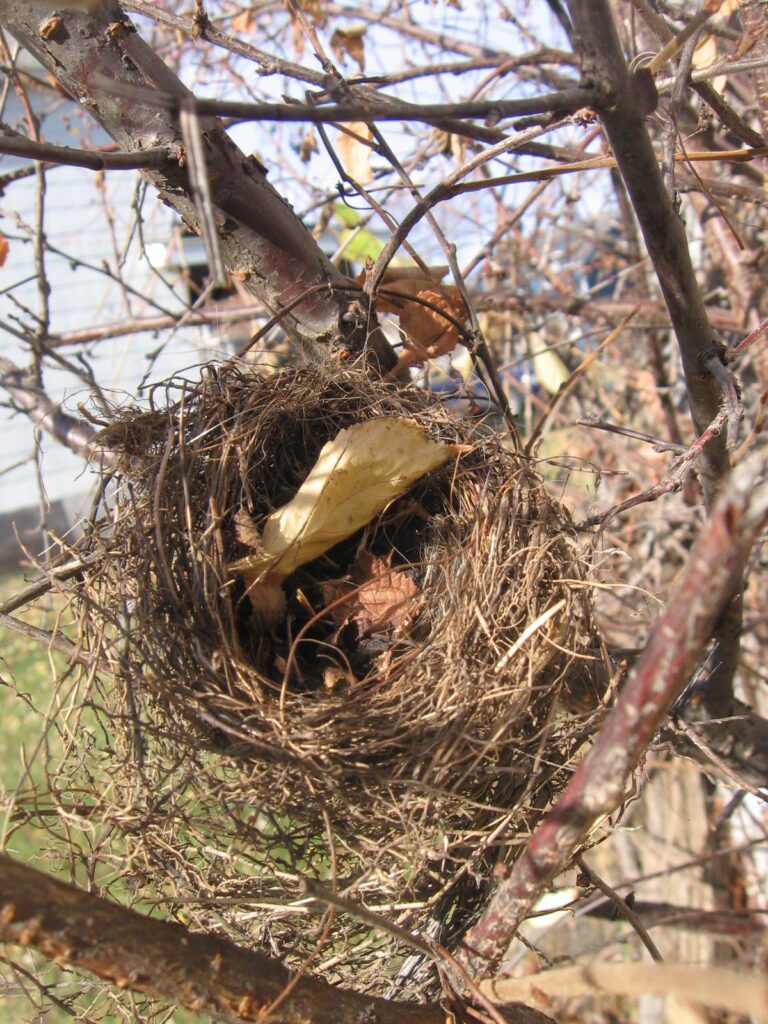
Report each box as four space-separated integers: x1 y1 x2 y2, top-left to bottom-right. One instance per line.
228 417 468 630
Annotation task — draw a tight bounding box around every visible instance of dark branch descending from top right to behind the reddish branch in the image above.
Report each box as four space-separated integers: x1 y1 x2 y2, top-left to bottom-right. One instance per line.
568 0 729 507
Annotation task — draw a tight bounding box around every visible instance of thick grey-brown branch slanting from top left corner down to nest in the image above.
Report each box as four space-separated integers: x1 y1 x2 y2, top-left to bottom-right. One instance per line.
0 0 382 365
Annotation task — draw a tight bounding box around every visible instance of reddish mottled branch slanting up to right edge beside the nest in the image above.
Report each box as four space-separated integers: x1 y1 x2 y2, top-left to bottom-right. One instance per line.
456 461 768 976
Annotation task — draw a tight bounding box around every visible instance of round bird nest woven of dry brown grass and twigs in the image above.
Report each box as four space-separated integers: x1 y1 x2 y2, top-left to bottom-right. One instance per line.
70 366 604 991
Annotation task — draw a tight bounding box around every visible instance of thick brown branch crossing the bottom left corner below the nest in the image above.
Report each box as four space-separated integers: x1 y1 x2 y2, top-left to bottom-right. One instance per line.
0 854 445 1024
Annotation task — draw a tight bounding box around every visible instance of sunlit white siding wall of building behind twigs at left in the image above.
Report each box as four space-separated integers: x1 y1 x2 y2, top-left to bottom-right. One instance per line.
0 95 231 512
